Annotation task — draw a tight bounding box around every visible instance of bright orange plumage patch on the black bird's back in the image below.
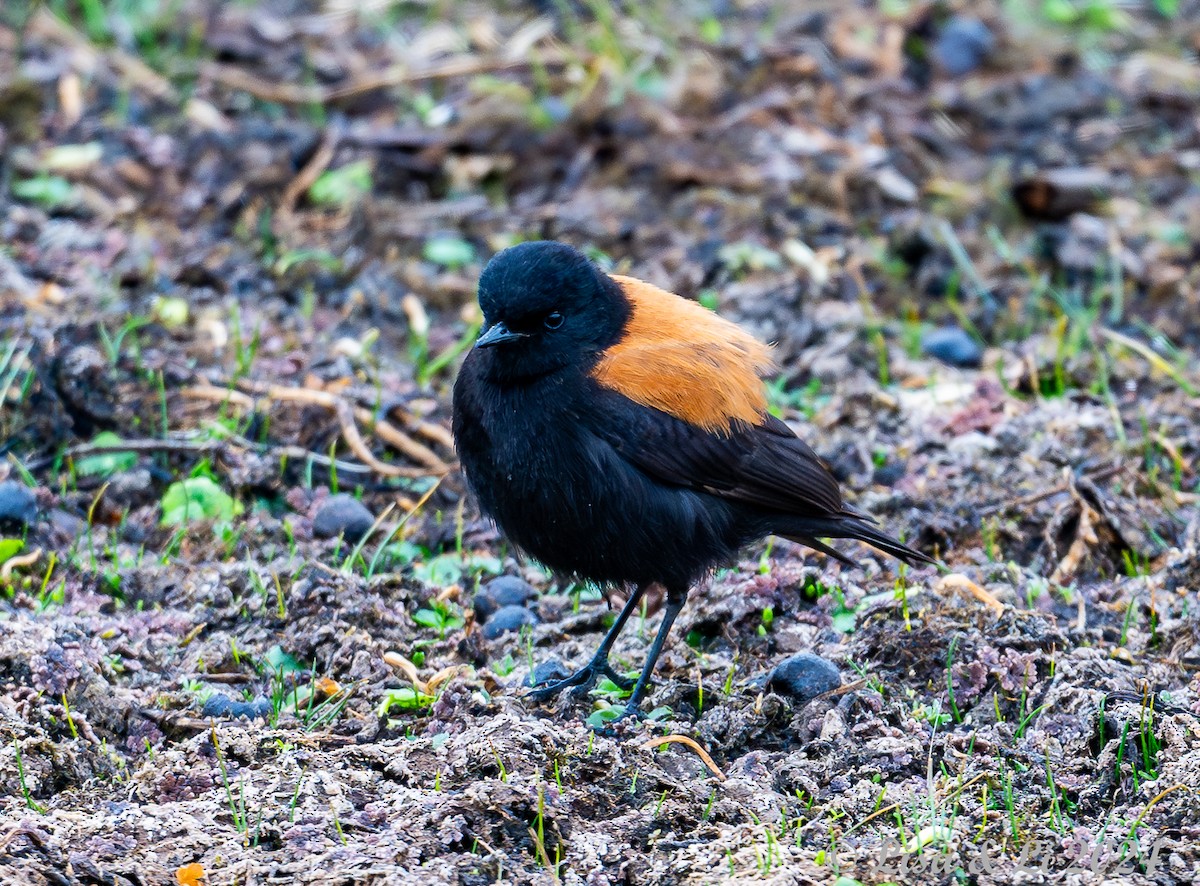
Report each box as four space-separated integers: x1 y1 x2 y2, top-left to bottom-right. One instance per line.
593 275 775 433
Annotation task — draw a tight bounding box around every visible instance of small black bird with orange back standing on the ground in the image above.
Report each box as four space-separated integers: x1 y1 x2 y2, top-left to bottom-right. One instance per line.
452 240 936 719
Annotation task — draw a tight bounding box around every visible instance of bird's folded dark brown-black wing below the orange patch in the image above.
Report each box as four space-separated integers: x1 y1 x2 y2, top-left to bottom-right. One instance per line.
580 388 856 516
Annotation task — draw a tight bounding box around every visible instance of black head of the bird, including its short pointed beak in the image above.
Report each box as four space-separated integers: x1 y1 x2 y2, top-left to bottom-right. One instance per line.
475 240 630 379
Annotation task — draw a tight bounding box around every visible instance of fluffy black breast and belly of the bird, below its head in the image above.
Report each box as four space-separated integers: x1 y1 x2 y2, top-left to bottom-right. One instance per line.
455 360 737 586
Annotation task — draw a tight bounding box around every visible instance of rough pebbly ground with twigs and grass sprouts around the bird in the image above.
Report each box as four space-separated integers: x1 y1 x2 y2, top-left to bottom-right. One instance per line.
0 0 1200 885
